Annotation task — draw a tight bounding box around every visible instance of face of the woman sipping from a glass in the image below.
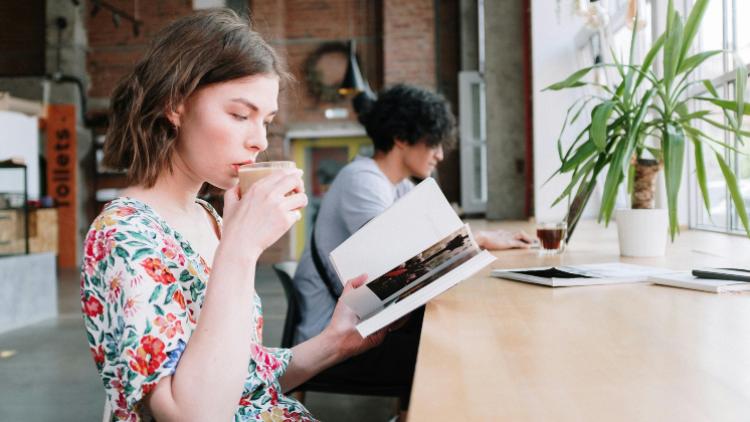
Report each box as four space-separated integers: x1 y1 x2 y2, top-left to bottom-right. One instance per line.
175 75 279 189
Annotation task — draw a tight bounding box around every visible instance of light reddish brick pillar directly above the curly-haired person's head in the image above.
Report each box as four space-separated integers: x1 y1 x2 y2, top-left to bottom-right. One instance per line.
383 0 435 89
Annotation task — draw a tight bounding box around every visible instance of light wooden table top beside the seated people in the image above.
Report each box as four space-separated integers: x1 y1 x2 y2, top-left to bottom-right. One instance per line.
409 221 750 422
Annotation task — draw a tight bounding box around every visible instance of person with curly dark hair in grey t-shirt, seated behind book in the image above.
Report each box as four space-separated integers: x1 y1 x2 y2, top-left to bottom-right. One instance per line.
294 85 531 418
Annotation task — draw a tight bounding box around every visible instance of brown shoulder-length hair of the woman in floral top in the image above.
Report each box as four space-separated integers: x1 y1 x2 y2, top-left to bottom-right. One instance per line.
103 9 291 187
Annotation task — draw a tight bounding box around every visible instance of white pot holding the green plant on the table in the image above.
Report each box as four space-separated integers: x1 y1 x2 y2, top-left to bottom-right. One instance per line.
615 209 669 257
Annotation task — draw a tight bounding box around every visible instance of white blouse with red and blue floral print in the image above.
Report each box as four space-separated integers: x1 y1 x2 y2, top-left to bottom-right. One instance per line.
81 198 314 421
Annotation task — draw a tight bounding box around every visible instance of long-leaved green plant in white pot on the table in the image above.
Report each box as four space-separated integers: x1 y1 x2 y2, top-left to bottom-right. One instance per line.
545 0 750 256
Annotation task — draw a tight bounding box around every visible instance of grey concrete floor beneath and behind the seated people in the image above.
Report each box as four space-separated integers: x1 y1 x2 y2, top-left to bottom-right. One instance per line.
0 266 396 422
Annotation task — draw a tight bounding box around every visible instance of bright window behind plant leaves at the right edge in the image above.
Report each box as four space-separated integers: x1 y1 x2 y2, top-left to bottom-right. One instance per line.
687 0 750 233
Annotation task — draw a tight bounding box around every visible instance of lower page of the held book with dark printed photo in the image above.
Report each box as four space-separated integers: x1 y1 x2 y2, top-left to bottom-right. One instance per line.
342 225 480 319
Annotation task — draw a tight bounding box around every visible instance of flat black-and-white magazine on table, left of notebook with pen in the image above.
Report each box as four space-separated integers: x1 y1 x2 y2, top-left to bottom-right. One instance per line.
491 262 674 287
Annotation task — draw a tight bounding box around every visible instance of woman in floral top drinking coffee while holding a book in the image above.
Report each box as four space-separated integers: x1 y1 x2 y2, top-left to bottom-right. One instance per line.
81 10 384 422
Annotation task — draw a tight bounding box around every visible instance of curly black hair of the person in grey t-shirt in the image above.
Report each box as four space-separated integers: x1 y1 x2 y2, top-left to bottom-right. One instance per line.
359 84 456 152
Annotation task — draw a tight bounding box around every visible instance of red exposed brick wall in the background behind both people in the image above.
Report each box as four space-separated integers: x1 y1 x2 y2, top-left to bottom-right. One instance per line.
87 0 436 134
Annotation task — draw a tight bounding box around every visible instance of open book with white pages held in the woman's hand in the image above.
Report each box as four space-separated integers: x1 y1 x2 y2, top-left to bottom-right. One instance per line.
330 178 495 337
